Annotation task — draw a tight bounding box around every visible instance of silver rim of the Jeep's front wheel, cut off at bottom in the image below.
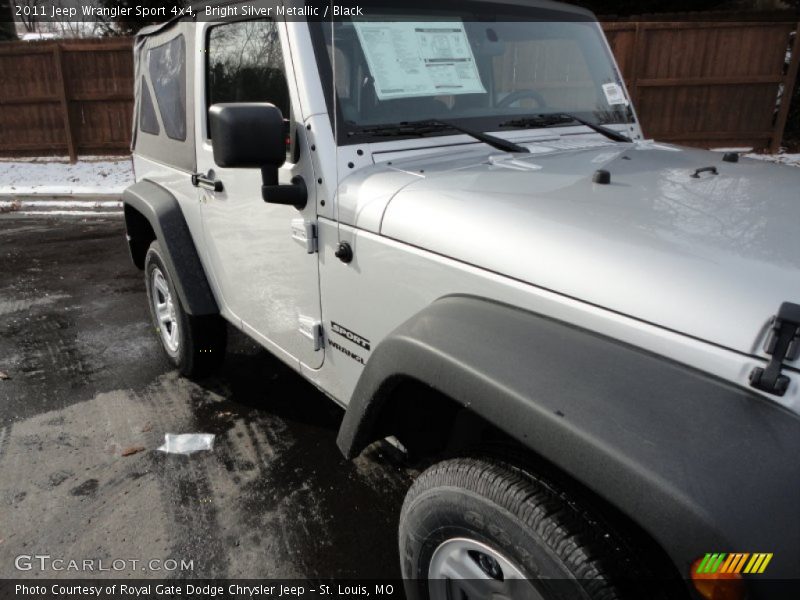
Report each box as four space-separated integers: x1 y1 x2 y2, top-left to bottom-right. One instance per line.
428 538 544 600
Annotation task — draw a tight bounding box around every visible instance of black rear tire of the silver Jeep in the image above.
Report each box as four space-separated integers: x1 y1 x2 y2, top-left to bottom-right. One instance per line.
144 241 227 378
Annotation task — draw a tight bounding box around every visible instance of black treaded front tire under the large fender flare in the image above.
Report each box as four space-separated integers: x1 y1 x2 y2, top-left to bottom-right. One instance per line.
399 458 673 600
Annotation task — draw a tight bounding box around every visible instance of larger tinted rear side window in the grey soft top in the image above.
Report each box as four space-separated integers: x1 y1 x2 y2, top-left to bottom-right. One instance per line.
148 35 186 141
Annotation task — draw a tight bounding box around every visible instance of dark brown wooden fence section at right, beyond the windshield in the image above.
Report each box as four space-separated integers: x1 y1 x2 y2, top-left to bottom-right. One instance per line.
603 22 800 152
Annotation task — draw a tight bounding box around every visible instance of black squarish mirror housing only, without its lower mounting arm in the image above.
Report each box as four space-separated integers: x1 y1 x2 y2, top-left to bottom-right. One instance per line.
208 102 286 169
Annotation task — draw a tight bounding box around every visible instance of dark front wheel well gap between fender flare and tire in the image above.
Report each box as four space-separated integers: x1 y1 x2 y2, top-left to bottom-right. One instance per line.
373 379 684 581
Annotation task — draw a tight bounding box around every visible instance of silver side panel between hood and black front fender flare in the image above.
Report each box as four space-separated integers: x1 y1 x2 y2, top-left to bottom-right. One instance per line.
316 219 800 413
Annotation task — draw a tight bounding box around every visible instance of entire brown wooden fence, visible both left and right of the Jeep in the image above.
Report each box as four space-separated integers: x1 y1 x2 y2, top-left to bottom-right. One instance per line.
0 21 800 160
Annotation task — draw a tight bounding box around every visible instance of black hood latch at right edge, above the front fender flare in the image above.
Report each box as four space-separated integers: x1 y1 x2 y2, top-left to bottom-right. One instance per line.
750 302 800 396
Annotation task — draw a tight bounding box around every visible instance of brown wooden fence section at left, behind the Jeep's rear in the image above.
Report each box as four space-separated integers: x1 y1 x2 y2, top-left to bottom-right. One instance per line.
0 38 133 161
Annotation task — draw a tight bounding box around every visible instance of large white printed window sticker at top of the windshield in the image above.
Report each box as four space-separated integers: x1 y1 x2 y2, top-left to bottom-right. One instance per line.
353 21 486 100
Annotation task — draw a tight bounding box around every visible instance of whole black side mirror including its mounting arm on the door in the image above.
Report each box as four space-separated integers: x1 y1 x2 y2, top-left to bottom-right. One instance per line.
208 102 308 209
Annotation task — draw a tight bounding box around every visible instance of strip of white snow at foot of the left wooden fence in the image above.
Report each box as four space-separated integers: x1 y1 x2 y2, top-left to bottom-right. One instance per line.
0 156 133 196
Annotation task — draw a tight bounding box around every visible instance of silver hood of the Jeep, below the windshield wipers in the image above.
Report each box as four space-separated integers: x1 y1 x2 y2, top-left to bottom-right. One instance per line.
376 140 800 356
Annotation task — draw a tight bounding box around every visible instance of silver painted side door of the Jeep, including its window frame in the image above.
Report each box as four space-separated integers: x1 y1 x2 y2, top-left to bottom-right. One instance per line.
195 18 324 369
